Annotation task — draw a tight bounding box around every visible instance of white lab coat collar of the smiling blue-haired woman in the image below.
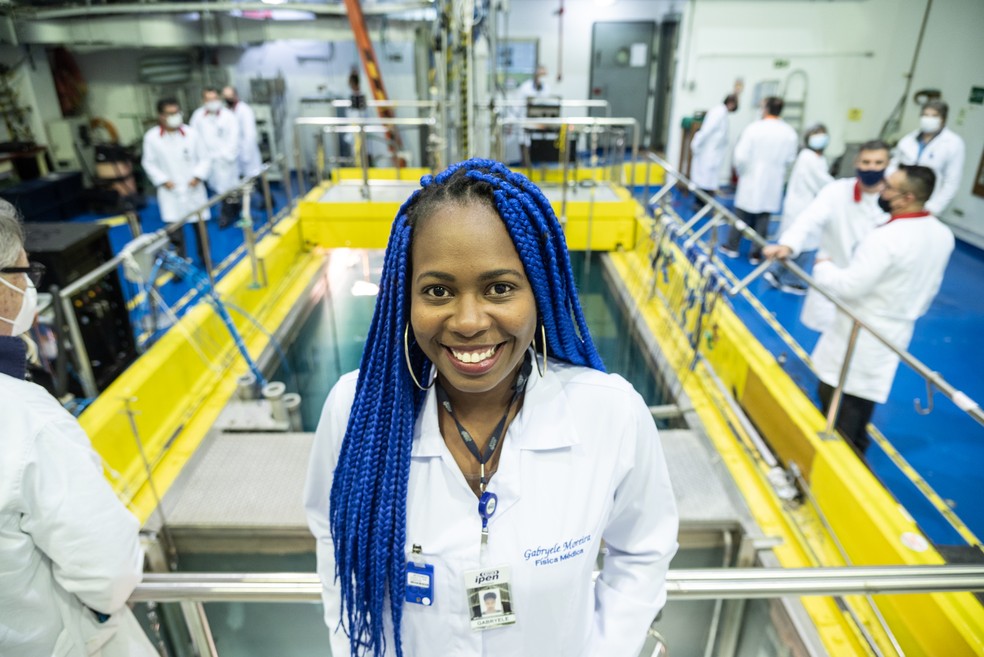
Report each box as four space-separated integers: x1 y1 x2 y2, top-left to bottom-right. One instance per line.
411 356 581 457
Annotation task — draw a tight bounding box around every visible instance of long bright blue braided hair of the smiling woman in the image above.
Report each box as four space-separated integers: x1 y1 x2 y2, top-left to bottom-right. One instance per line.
329 159 604 657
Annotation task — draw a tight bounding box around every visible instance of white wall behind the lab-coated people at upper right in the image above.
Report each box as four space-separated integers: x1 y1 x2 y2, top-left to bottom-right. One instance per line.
668 0 984 243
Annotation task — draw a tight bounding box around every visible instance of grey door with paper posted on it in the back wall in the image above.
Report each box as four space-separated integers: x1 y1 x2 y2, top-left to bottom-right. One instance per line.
588 21 656 145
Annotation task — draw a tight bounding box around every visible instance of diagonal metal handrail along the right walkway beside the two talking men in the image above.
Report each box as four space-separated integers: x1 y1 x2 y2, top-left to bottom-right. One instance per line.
647 153 984 432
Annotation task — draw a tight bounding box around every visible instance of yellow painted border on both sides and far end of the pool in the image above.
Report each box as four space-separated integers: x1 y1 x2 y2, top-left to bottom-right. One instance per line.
81 167 984 657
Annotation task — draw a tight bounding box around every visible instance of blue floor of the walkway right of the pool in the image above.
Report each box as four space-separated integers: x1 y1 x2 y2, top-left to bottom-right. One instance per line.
648 184 984 546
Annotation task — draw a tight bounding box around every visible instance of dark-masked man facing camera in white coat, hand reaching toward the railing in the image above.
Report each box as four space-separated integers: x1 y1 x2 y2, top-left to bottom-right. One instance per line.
762 139 889 332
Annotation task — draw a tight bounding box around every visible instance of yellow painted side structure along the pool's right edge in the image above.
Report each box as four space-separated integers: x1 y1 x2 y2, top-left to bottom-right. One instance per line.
611 213 984 657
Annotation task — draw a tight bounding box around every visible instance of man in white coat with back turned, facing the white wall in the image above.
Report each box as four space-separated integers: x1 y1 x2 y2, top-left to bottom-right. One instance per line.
721 96 799 263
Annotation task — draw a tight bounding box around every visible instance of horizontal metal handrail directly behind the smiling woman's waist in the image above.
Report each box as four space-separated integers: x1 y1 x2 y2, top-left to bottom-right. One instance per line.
130 565 984 602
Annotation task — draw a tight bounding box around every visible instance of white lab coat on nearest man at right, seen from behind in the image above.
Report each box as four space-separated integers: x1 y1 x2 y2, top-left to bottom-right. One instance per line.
812 215 954 403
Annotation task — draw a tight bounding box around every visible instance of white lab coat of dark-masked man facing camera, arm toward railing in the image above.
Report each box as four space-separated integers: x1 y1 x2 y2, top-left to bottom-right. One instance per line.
779 178 888 332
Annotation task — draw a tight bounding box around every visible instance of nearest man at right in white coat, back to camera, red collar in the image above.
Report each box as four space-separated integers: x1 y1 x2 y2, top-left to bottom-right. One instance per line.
812 165 954 455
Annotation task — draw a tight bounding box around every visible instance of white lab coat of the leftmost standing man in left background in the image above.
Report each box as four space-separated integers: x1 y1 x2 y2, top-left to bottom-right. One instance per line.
140 125 209 223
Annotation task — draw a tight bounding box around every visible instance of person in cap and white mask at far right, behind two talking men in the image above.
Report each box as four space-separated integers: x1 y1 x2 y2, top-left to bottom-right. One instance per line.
890 100 964 216
